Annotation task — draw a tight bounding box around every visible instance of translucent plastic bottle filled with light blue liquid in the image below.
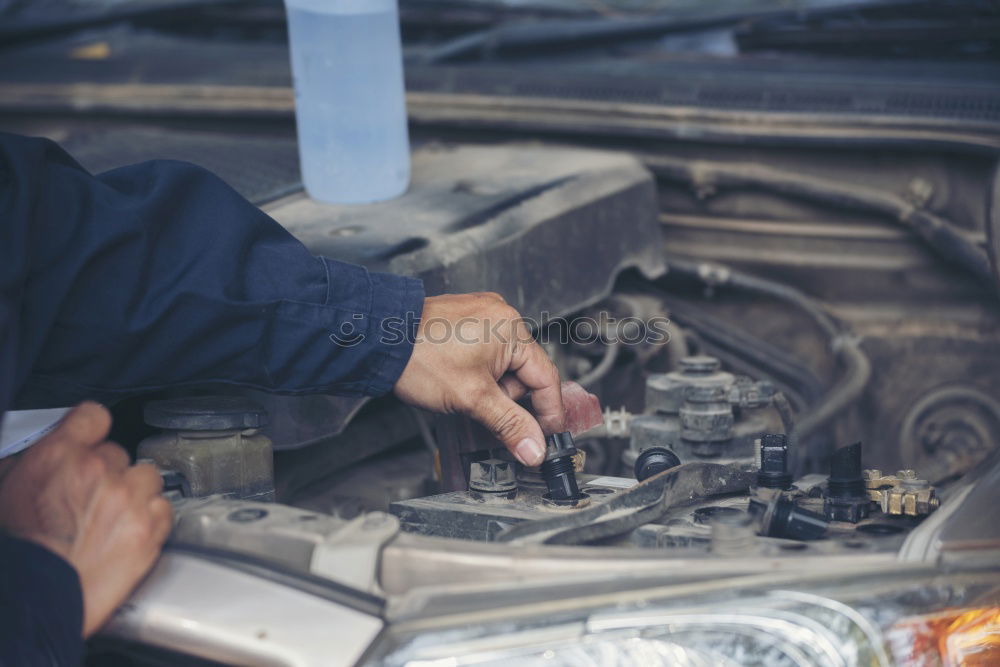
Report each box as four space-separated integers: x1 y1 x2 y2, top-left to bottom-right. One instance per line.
285 0 410 203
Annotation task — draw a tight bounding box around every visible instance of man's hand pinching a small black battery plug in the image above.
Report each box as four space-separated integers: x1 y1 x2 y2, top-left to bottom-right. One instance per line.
395 293 564 465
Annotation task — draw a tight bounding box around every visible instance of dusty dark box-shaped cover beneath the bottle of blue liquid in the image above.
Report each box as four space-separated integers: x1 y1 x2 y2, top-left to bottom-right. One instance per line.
265 144 664 317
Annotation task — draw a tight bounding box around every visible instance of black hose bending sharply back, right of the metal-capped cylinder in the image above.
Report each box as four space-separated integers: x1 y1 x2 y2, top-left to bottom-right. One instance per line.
667 257 871 452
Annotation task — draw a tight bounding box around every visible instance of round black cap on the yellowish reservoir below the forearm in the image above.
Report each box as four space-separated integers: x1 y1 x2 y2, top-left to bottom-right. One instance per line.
142 396 267 431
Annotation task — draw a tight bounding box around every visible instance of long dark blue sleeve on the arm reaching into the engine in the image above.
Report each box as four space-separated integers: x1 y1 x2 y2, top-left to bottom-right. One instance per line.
0 134 423 409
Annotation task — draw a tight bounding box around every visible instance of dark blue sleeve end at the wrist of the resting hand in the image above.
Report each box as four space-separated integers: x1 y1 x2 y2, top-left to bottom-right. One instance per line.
0 534 83 667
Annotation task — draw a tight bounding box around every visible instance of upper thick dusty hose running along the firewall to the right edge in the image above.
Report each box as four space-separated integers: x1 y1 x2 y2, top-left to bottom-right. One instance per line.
644 157 996 291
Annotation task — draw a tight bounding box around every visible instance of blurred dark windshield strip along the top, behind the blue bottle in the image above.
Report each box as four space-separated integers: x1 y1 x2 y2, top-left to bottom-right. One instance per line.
0 0 1000 64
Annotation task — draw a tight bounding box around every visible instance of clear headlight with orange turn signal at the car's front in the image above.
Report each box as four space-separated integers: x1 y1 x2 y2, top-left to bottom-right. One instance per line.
380 570 1000 667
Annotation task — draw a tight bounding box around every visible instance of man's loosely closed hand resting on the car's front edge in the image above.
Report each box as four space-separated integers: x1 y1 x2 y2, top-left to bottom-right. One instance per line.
0 403 172 637
